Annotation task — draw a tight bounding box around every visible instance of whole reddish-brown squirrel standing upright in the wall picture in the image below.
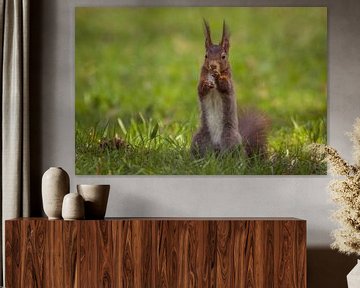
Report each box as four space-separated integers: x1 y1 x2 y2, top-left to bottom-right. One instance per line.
191 19 270 157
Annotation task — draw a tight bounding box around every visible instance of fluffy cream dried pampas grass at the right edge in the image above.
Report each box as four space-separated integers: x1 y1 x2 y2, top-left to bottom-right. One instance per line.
310 118 360 255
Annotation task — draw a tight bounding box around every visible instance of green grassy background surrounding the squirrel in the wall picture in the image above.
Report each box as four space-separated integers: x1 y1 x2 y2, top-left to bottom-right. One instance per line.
75 8 327 175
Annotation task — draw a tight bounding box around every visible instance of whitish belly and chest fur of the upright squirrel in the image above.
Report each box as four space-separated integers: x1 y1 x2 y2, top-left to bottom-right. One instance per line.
204 76 224 144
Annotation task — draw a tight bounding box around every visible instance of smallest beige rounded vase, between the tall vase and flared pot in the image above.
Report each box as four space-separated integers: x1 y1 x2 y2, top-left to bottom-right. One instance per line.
62 192 85 220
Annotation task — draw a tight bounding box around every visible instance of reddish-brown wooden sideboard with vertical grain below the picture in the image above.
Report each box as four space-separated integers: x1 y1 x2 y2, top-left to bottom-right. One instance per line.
5 218 306 288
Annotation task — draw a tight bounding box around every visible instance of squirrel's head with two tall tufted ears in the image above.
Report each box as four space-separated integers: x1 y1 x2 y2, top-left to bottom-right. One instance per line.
204 20 230 73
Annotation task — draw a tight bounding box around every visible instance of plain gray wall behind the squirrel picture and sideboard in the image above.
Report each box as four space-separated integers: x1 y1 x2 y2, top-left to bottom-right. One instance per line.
30 0 360 287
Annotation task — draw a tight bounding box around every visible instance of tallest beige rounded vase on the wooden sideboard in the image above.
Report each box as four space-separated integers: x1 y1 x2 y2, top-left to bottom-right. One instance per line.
41 167 70 219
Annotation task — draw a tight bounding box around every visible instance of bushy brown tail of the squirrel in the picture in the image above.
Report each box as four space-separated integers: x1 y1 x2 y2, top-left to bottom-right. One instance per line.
239 109 270 157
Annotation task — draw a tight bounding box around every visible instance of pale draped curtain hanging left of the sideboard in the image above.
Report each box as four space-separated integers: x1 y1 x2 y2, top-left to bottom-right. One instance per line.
0 0 30 283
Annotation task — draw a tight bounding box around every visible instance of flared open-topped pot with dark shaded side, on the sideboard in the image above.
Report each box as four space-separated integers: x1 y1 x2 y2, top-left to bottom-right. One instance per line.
77 184 110 219
